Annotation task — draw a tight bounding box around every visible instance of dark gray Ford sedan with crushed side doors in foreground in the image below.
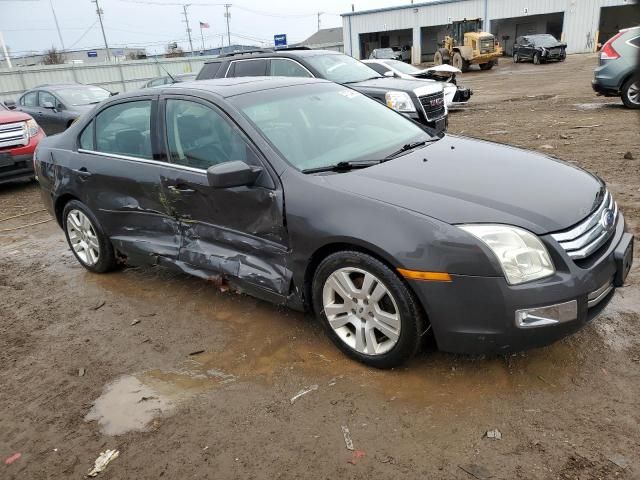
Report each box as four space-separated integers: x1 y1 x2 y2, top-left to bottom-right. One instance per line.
36 77 633 368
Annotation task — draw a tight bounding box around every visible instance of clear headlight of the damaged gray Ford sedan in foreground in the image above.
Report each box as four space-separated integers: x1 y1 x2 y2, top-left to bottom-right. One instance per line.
460 225 556 285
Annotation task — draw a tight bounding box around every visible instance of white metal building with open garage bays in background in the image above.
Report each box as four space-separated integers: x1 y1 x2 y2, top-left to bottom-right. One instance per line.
342 0 640 63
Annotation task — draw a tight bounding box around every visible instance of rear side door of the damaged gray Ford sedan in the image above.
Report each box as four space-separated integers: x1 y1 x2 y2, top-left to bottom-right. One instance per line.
76 95 180 264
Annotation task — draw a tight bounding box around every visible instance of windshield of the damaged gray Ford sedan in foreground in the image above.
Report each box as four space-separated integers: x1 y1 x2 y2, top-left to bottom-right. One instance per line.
232 83 431 170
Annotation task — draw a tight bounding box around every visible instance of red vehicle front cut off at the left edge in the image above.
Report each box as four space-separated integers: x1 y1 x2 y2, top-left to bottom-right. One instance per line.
0 102 45 183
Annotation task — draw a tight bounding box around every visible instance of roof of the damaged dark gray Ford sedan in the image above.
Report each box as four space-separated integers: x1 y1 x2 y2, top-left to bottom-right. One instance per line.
117 77 332 98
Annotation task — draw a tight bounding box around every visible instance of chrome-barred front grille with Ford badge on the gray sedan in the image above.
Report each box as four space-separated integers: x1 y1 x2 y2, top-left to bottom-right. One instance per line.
551 191 618 260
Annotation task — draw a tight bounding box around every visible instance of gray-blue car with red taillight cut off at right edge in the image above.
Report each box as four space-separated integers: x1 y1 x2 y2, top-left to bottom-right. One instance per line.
591 27 640 108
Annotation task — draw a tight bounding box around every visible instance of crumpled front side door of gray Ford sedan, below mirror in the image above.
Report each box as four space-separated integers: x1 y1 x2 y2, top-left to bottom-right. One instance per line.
161 95 291 299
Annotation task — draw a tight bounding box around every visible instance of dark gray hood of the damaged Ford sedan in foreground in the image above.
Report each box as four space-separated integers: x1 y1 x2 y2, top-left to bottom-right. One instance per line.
324 135 604 234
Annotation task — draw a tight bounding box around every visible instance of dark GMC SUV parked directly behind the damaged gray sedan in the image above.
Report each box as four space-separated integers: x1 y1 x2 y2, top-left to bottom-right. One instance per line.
197 48 448 132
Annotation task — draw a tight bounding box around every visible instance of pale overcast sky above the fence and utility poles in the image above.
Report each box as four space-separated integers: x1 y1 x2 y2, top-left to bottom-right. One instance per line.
0 0 410 57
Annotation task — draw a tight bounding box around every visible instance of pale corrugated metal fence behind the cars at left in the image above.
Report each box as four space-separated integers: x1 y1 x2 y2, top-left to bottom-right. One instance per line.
0 56 215 101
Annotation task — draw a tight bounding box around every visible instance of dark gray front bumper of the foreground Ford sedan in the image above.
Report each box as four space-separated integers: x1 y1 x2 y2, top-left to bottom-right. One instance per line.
411 215 629 354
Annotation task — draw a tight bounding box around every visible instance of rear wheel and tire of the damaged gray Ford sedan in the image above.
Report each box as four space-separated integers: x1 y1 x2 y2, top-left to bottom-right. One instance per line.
62 200 116 273
